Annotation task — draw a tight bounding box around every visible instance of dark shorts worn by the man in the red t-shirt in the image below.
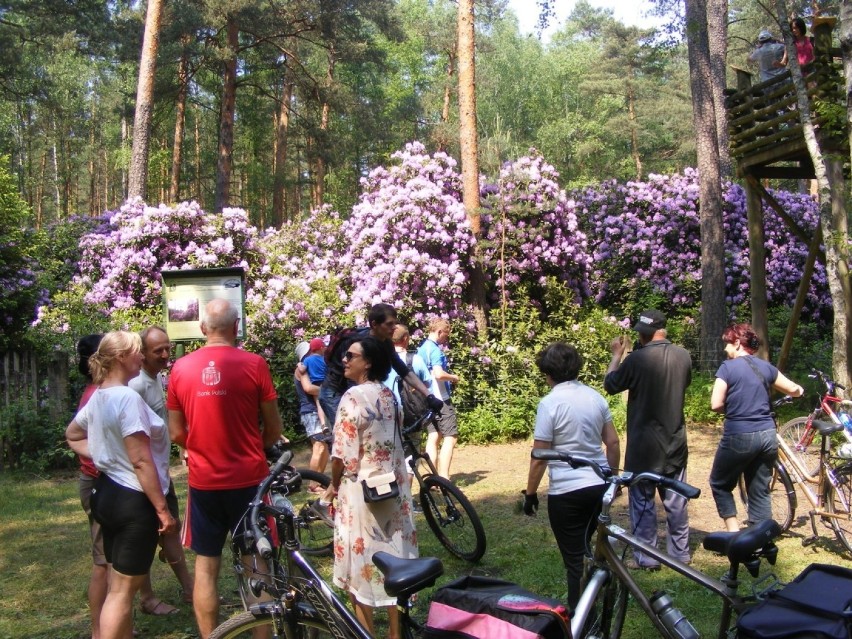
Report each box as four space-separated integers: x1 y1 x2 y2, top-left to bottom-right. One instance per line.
189 486 257 557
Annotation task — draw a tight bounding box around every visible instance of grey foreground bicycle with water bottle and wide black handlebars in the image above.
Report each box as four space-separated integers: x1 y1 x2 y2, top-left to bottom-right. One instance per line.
532 449 781 639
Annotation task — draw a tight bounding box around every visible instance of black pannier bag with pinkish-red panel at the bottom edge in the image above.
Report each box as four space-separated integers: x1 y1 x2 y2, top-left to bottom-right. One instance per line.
423 576 571 639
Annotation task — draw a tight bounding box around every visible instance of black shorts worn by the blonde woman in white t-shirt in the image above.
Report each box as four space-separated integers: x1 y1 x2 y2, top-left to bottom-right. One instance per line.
91 473 160 576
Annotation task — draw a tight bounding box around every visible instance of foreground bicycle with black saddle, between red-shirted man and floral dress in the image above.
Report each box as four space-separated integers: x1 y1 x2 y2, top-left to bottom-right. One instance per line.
210 451 443 639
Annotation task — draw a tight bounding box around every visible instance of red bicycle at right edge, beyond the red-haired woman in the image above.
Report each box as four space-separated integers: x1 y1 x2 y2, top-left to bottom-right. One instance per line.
778 368 852 483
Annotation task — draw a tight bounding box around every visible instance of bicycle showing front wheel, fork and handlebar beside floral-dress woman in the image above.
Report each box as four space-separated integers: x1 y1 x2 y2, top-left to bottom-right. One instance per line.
402 411 486 562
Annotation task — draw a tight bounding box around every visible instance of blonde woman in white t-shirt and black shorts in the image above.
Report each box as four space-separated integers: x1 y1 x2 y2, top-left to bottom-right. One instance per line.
65 331 177 639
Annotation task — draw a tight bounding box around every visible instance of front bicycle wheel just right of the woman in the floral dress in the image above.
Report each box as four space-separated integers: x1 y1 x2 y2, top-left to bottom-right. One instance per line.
420 475 485 561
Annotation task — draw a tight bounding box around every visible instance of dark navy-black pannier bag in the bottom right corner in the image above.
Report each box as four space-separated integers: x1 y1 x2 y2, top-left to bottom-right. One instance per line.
737 564 852 639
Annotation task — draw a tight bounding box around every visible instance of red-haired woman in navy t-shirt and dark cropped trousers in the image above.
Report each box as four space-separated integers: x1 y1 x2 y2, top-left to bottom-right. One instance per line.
710 324 804 531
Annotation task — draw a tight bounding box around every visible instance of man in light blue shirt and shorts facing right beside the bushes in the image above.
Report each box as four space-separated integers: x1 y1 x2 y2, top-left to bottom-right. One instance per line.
417 317 459 479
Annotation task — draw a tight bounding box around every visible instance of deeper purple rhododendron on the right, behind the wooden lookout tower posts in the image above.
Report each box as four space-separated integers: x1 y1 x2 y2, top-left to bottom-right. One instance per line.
574 169 831 311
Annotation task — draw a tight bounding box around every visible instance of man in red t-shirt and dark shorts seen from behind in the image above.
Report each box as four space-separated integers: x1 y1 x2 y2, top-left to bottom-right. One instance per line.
166 299 281 639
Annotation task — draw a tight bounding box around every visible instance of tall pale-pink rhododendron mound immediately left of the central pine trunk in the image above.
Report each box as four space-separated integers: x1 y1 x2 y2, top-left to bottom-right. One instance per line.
341 142 474 321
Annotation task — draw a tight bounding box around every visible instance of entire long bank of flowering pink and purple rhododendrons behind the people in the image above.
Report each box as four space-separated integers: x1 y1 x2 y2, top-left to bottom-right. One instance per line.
30 142 830 370
